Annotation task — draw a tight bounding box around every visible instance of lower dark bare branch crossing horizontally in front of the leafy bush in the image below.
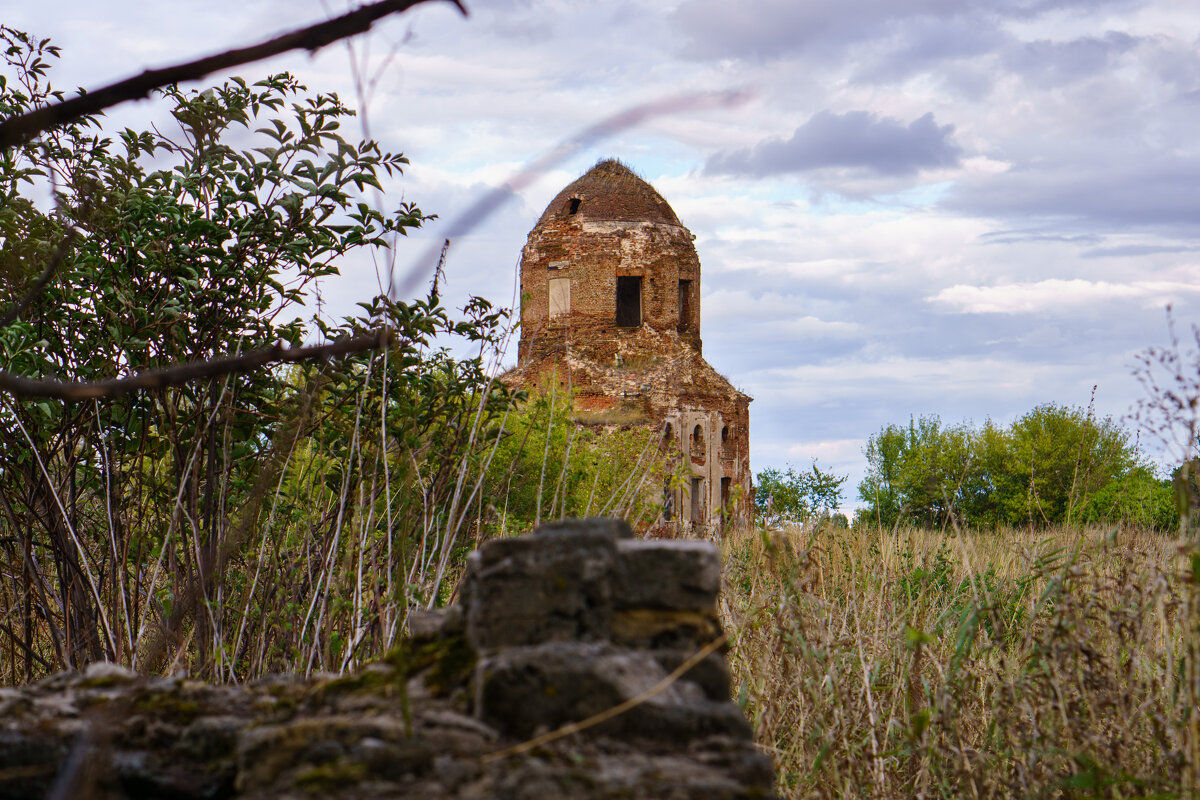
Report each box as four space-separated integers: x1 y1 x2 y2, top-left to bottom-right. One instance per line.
0 327 391 401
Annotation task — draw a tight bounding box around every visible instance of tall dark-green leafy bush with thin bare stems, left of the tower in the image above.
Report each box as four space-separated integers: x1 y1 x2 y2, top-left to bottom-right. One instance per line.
0 29 508 680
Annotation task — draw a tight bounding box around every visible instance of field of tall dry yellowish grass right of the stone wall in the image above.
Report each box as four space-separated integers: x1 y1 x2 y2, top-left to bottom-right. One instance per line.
721 529 1190 798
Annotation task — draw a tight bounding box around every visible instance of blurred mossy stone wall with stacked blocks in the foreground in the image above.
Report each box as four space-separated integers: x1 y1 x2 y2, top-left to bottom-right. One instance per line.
0 519 774 800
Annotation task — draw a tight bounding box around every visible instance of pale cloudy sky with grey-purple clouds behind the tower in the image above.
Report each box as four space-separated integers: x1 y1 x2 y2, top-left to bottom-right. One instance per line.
4 0 1200 501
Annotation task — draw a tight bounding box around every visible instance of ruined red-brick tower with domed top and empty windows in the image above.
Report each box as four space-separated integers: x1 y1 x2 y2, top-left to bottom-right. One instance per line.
505 160 750 524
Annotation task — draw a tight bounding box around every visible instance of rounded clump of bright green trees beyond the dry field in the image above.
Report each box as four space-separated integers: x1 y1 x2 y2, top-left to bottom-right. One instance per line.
858 403 1164 528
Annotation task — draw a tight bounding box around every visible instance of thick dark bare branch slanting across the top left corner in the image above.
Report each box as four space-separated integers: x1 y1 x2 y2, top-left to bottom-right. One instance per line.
0 0 467 150
